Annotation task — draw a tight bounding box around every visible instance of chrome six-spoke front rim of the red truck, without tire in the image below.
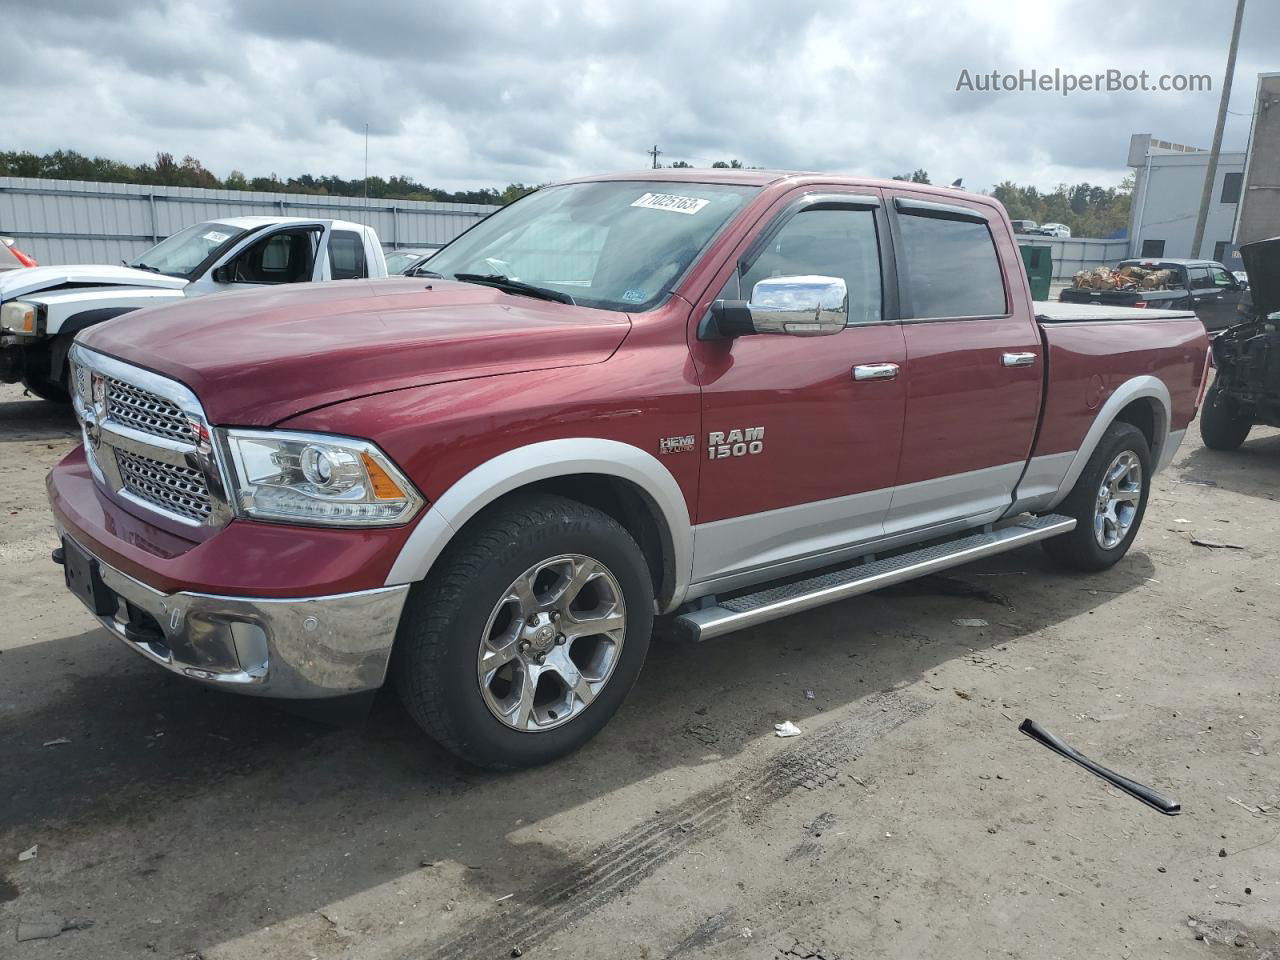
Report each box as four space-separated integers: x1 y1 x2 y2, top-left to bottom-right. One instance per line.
476 553 627 733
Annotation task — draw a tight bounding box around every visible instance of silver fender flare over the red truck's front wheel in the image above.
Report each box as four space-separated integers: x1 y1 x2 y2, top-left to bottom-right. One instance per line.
385 436 694 605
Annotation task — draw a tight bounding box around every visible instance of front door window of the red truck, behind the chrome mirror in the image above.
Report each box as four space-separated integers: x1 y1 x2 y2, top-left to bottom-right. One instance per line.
739 209 882 324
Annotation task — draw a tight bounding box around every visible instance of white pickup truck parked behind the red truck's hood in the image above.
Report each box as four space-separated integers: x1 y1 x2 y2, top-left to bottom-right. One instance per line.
0 216 387 402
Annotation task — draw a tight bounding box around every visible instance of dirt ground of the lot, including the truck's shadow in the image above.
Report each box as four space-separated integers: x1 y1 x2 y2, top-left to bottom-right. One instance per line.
0 378 1280 960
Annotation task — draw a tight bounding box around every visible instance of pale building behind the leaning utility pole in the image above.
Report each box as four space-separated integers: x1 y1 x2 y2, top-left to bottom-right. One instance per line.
1129 133 1245 262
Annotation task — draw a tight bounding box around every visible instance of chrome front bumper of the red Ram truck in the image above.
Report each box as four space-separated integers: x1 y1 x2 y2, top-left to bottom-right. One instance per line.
59 531 408 699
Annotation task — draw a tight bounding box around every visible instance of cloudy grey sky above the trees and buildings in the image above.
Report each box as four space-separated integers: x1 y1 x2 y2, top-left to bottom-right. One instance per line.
0 0 1280 188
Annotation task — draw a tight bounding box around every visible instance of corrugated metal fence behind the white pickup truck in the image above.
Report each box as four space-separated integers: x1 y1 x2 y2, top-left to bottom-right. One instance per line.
0 177 498 264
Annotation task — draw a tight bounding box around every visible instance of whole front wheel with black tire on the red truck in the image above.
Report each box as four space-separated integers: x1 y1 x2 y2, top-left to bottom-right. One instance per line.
392 494 654 769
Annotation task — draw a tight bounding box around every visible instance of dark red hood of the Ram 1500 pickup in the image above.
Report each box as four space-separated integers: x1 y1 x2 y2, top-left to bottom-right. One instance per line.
77 278 631 426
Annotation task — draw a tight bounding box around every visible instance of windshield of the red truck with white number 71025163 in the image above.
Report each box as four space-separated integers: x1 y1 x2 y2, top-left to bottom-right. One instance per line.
421 180 759 312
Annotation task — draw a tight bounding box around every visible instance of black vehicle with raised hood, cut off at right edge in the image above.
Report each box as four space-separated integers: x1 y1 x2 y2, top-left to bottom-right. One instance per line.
1201 237 1280 451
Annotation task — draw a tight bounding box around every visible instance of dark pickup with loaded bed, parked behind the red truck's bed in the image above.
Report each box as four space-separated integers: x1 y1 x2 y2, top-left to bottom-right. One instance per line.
1059 259 1252 330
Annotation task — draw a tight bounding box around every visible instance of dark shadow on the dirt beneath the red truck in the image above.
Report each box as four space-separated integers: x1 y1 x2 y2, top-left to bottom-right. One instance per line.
0 548 1155 956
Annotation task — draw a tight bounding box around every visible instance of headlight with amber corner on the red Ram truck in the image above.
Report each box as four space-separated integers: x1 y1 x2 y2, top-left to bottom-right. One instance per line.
224 430 422 526
